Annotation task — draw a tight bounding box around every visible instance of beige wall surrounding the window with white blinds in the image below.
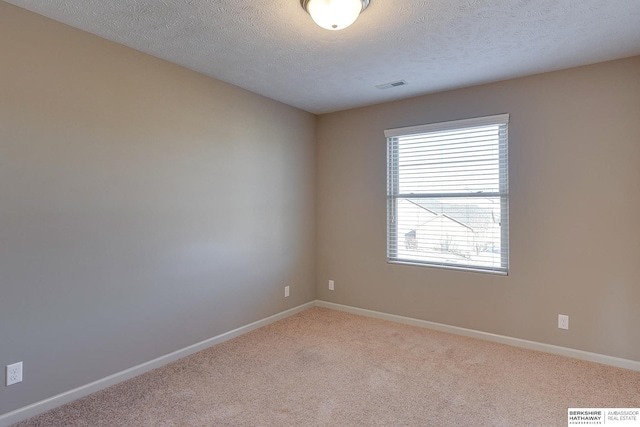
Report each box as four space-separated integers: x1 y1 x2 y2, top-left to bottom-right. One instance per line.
317 57 640 361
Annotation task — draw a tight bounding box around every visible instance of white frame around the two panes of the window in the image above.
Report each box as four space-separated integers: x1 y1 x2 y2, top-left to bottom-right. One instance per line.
384 113 510 275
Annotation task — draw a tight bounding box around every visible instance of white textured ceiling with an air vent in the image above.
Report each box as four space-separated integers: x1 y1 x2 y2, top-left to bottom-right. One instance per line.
8 0 640 113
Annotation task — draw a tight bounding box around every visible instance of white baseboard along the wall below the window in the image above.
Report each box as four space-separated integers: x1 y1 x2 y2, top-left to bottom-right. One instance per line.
316 300 640 371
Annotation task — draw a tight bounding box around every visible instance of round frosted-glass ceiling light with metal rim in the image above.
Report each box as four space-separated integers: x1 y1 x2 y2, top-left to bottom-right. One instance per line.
300 0 369 30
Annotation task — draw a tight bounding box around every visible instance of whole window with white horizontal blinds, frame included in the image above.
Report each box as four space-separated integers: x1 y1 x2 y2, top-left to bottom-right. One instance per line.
385 114 509 274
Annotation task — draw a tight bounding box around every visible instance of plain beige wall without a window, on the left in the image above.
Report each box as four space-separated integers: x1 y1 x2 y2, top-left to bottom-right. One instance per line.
0 2 316 414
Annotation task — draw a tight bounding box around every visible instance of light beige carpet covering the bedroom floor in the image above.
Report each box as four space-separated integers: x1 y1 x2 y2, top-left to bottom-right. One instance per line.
15 307 640 427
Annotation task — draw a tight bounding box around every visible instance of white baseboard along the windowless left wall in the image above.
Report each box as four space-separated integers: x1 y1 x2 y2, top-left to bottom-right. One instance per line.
0 301 316 427
